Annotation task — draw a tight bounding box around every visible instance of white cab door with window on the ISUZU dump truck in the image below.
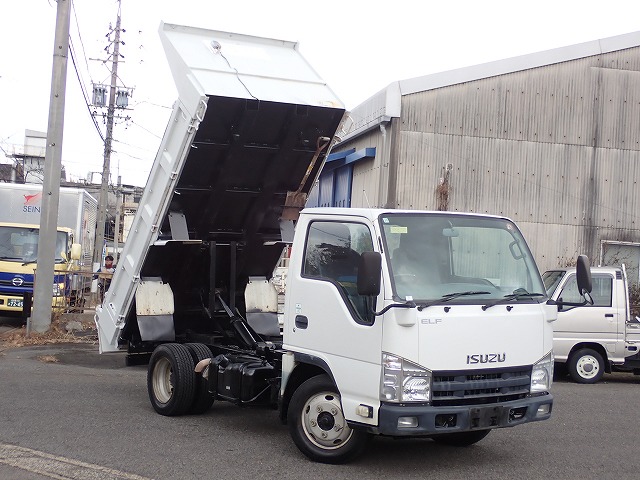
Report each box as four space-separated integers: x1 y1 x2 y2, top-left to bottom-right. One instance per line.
284 221 382 422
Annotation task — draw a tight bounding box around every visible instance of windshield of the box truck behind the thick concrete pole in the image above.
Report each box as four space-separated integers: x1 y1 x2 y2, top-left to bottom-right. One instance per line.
0 226 67 263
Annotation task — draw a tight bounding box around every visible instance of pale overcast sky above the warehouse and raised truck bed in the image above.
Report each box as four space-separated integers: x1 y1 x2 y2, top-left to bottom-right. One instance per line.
0 0 640 186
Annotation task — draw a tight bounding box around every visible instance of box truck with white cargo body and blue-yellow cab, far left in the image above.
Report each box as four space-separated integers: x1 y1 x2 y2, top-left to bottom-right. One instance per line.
0 183 98 315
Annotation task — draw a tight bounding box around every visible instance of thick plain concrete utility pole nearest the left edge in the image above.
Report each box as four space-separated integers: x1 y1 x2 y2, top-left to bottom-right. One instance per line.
30 0 71 333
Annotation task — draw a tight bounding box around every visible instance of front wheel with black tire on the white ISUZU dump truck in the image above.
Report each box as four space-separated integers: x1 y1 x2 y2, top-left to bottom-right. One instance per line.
287 375 370 464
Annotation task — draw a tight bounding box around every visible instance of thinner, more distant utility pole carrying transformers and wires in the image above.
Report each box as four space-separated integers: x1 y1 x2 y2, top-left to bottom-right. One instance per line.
93 0 120 267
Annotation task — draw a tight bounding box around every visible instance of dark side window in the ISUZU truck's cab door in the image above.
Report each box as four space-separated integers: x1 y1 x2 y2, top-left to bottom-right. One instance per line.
302 222 373 320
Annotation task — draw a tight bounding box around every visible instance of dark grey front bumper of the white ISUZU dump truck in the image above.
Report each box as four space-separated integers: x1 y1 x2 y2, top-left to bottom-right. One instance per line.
375 394 553 437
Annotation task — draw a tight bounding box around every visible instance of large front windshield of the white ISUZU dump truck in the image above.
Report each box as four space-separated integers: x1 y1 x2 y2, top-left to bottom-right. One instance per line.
381 213 546 303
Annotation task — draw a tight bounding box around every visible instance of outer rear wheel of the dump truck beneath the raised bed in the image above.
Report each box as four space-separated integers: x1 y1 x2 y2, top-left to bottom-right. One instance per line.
147 343 196 416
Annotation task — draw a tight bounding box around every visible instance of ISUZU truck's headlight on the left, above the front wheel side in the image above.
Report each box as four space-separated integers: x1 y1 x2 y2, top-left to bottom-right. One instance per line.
380 353 431 403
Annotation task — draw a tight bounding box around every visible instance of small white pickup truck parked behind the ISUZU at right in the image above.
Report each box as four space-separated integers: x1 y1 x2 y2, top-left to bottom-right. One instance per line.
543 266 640 383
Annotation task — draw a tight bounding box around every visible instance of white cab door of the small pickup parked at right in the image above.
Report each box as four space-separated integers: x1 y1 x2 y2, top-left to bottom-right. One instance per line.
554 273 624 359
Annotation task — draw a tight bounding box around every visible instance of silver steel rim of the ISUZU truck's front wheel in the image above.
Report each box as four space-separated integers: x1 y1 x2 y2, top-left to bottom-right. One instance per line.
302 392 353 450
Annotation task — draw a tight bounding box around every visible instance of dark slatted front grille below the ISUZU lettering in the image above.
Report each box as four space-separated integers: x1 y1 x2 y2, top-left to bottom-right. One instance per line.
432 367 531 406
